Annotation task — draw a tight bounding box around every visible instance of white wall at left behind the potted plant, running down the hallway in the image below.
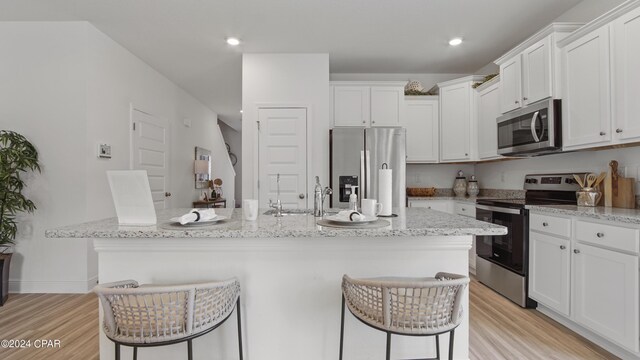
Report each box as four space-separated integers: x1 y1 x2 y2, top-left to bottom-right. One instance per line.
0 22 233 292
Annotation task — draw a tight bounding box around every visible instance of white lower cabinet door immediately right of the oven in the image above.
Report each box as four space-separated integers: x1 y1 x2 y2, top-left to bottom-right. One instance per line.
529 231 571 316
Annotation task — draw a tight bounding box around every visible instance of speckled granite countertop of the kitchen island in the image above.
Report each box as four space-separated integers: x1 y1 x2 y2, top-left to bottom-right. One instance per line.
45 208 507 238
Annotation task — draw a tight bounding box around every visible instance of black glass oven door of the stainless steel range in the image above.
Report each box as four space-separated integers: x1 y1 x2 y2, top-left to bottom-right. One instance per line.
476 204 528 275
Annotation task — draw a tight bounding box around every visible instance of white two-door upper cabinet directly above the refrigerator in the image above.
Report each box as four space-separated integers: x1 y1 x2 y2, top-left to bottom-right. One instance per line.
331 81 405 127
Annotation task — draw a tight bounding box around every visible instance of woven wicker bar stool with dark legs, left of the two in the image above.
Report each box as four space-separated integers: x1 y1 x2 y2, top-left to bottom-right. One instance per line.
93 279 242 360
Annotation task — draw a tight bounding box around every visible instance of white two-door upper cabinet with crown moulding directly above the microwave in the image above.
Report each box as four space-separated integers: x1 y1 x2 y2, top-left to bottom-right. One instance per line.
495 23 582 113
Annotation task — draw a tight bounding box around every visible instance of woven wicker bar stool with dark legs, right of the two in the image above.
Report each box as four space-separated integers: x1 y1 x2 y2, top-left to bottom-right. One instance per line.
340 272 469 360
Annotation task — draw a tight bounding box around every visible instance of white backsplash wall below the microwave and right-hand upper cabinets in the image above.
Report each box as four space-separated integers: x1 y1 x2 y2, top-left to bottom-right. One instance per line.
476 147 640 194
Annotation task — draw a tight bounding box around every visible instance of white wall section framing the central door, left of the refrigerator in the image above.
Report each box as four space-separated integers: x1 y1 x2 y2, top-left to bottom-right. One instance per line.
242 54 329 204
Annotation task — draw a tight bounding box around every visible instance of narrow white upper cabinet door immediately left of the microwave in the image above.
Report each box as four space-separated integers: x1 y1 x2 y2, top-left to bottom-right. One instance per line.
476 83 500 160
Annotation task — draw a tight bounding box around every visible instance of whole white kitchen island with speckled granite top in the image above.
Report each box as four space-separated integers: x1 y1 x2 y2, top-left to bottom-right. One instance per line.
46 208 507 360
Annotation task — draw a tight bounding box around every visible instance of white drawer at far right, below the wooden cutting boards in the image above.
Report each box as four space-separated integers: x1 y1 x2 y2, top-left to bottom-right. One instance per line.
576 220 640 253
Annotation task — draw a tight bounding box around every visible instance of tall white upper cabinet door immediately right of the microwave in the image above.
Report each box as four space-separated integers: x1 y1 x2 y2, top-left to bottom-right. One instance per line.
562 26 611 149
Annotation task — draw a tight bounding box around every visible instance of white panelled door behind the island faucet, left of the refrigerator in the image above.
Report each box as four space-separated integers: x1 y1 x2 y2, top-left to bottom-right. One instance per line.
258 108 307 209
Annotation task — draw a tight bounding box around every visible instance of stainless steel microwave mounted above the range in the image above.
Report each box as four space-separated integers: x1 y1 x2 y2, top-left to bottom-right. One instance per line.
497 99 562 156
